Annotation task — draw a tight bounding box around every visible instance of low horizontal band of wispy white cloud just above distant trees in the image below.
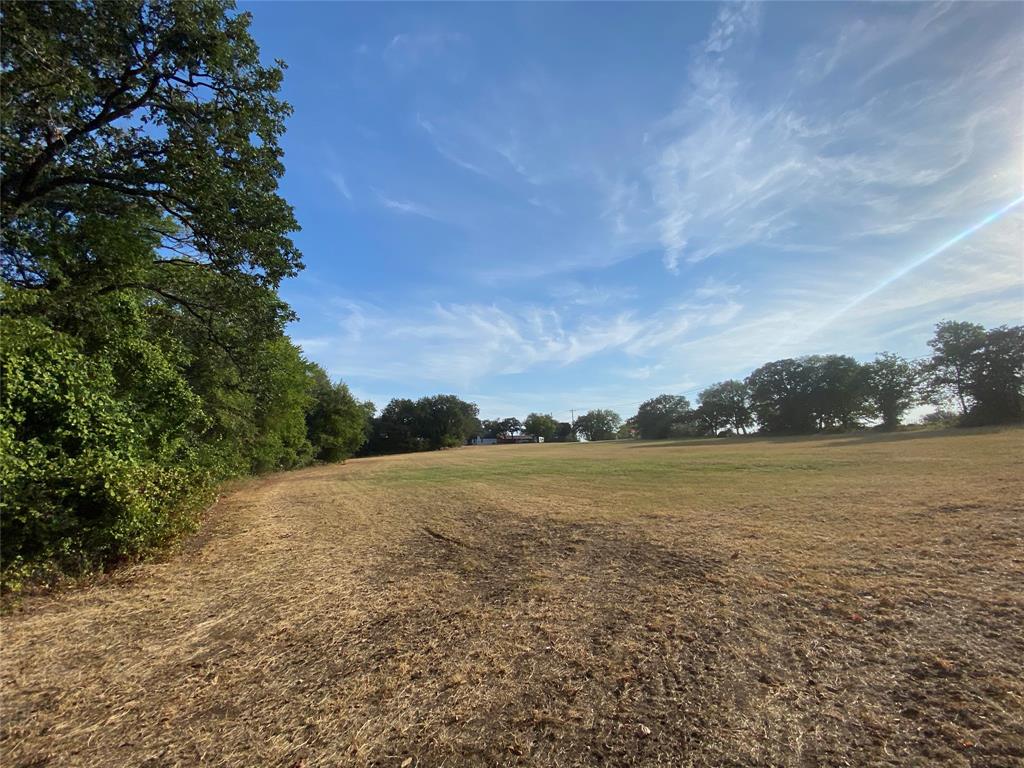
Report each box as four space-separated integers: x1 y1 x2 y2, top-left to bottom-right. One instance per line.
303 284 741 386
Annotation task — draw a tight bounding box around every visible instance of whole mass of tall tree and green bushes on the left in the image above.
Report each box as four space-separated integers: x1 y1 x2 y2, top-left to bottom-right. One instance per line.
0 0 372 588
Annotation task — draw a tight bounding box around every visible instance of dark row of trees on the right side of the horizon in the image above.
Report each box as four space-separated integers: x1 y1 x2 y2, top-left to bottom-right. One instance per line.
628 321 1024 439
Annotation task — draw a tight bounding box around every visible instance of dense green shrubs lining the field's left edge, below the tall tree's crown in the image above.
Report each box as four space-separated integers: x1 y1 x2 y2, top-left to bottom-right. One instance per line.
0 293 368 589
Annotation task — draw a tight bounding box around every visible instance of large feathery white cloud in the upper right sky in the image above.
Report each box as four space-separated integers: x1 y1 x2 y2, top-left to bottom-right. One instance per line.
634 1 1024 271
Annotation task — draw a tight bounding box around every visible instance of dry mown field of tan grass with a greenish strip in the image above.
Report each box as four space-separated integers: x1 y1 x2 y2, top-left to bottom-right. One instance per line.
0 429 1024 768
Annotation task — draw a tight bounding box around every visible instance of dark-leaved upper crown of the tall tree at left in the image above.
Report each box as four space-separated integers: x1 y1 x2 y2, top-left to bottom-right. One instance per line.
0 0 300 288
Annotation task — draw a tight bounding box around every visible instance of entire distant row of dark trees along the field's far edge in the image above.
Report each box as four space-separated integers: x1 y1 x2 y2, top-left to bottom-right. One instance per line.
361 322 1024 455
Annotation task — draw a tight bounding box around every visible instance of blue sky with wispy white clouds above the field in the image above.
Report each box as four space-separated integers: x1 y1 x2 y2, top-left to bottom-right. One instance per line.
243 2 1024 418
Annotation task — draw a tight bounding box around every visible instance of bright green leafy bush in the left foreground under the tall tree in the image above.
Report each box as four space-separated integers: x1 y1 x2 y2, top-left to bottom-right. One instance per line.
0 317 211 588
